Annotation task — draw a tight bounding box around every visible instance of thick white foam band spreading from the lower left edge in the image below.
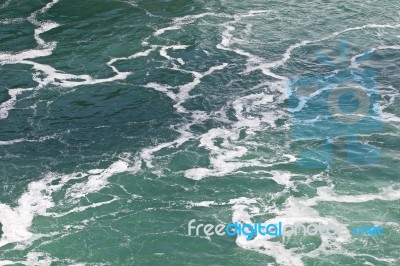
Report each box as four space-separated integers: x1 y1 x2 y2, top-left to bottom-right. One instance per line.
0 161 136 248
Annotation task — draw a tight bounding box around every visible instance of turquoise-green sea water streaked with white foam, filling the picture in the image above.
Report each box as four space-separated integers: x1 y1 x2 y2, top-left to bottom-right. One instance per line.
0 0 400 265
